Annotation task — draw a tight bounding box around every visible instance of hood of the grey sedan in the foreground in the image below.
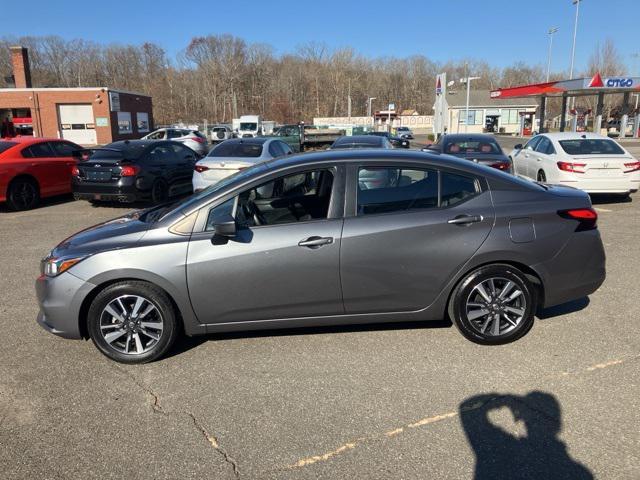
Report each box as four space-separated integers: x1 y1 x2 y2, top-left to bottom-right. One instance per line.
50 210 152 257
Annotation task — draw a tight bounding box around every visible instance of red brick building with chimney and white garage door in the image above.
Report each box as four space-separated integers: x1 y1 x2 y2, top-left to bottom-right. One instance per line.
0 47 153 145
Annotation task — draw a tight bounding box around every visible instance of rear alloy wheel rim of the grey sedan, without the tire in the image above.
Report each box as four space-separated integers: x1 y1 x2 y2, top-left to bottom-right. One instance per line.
465 277 527 337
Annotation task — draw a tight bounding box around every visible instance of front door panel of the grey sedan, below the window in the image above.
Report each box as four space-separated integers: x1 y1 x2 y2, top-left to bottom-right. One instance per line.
187 219 344 323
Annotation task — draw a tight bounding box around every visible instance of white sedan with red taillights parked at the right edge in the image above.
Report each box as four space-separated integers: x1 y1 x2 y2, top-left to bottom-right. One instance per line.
509 132 640 196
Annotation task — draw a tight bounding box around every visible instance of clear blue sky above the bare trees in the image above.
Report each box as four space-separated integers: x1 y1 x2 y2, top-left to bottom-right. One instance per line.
5 0 640 75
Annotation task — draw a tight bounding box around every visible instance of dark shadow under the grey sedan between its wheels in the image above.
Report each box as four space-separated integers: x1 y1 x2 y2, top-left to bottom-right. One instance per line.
163 320 453 358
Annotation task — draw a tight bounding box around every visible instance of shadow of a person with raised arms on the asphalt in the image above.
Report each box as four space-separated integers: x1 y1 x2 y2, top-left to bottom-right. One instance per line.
459 391 594 480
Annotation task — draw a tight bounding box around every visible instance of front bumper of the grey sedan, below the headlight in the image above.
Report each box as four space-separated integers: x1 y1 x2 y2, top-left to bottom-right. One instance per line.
36 272 95 339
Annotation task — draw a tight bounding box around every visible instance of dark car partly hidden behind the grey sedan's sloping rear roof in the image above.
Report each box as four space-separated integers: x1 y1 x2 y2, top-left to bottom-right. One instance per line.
422 133 513 173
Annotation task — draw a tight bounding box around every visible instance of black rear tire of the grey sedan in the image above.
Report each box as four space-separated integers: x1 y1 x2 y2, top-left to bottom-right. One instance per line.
449 264 538 345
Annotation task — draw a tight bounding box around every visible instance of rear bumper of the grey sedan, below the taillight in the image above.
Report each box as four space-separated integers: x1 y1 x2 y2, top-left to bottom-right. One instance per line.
532 230 606 308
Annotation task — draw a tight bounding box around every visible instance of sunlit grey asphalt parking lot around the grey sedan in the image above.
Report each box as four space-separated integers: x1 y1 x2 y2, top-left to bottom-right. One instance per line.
0 138 640 479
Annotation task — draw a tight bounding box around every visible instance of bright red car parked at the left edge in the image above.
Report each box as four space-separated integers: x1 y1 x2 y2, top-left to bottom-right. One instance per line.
0 137 82 210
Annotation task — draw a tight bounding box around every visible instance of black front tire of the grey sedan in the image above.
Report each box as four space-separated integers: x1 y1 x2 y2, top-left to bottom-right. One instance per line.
87 280 179 363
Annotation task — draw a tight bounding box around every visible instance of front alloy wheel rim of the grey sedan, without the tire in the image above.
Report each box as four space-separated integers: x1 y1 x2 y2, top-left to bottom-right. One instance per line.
99 295 164 355
